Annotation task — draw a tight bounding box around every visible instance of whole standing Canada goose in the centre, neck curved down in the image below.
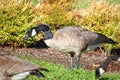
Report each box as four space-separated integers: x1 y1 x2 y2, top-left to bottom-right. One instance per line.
23 24 116 68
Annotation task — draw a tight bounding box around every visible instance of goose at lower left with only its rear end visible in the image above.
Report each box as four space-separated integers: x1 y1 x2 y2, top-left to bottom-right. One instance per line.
0 55 48 80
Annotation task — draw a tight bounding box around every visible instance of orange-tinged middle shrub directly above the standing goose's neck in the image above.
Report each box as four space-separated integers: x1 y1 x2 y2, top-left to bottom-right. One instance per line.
36 0 74 30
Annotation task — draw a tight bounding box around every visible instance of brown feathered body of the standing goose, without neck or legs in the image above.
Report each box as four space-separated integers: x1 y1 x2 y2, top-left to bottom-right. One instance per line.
45 26 115 55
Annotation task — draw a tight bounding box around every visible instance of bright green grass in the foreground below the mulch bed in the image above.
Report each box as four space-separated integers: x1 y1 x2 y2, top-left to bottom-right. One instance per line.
19 56 120 80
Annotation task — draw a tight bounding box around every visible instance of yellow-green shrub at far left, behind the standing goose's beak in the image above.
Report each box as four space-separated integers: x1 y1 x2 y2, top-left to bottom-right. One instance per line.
0 0 38 46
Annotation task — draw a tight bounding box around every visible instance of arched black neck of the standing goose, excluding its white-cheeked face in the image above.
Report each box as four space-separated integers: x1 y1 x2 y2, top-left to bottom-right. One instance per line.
36 24 53 40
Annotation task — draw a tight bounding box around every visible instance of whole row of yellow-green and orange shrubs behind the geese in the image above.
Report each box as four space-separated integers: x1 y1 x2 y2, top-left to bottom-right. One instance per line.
0 0 120 47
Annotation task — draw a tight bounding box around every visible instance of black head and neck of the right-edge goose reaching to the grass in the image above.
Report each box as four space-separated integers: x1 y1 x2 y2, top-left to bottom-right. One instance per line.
95 49 120 78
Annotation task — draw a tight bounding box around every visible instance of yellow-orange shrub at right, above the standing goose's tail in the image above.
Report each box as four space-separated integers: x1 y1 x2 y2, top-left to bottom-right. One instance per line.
71 0 120 50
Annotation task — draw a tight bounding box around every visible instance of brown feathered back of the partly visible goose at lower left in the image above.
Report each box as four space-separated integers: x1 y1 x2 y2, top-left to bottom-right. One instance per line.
0 55 46 80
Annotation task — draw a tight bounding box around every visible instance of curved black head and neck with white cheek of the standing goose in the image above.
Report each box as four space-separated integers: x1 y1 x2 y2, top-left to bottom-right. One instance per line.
23 24 53 41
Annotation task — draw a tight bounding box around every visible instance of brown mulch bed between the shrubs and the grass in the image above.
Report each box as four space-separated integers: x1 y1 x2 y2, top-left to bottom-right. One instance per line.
0 46 120 72
